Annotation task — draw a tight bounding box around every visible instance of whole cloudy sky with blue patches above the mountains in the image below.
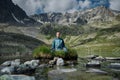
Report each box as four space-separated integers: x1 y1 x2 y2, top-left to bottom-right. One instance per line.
12 0 120 15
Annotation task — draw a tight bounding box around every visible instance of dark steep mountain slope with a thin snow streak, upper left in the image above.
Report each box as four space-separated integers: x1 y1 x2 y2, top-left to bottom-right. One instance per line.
0 0 36 24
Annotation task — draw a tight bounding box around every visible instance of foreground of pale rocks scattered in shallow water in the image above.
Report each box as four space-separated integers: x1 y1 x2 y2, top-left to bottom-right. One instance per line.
0 55 120 80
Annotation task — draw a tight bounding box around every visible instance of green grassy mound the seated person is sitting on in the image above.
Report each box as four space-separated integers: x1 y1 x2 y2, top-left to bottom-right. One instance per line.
33 46 78 60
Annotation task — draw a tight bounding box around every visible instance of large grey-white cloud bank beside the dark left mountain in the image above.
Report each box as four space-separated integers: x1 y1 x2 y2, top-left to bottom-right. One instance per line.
12 0 78 15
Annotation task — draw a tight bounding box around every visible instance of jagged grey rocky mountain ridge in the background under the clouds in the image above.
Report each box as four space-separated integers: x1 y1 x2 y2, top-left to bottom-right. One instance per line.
31 6 118 25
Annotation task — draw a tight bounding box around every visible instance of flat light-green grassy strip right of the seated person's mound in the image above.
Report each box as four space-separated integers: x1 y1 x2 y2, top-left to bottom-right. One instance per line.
77 45 120 57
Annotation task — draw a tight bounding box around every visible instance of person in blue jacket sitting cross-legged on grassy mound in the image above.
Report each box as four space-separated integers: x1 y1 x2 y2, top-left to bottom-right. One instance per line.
52 32 67 52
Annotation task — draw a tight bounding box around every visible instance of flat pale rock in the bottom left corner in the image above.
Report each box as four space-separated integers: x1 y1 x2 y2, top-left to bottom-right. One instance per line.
0 75 35 80
